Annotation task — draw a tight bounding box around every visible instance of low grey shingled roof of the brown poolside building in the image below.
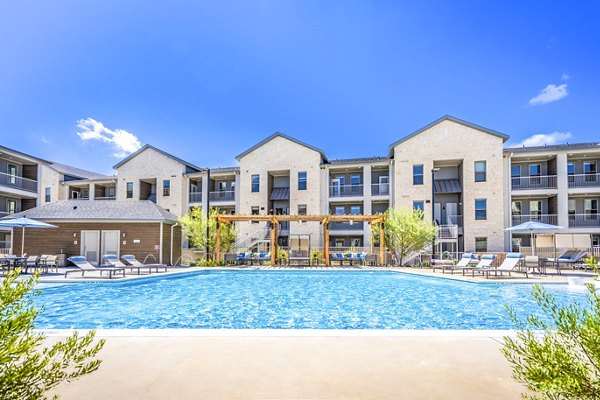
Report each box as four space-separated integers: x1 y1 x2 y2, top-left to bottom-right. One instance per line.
10 200 177 222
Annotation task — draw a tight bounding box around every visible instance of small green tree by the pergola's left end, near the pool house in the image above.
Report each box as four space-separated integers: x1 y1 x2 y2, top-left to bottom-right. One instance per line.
179 207 237 259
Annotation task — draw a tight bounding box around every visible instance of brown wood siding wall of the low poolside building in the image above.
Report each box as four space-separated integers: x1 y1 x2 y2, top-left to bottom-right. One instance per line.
13 221 181 263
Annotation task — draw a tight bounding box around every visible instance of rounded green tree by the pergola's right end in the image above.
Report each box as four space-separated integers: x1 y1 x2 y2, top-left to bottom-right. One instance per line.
372 207 435 265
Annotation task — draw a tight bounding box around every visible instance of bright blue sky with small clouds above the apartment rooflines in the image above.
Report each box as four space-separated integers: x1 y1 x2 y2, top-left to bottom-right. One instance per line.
0 0 600 173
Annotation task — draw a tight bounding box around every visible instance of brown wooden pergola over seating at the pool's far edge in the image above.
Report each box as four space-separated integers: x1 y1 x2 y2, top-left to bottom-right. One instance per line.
214 214 385 265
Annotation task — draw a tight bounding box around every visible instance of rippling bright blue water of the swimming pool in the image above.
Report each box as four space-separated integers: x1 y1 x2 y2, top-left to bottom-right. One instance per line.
34 270 584 329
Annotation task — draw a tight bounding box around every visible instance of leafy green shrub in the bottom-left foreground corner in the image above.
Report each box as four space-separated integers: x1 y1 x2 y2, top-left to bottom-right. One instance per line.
0 270 104 400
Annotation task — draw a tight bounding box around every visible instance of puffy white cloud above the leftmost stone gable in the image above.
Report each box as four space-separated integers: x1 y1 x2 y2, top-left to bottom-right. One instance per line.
77 118 142 158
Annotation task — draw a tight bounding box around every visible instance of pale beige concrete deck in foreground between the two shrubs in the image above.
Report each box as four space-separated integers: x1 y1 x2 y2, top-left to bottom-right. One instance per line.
48 335 524 400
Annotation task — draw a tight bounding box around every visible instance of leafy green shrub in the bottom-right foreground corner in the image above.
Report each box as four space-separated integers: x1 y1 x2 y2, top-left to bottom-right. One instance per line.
502 285 600 400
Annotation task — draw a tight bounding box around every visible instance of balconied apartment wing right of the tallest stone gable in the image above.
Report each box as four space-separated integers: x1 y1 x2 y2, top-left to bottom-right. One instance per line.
504 143 600 249
